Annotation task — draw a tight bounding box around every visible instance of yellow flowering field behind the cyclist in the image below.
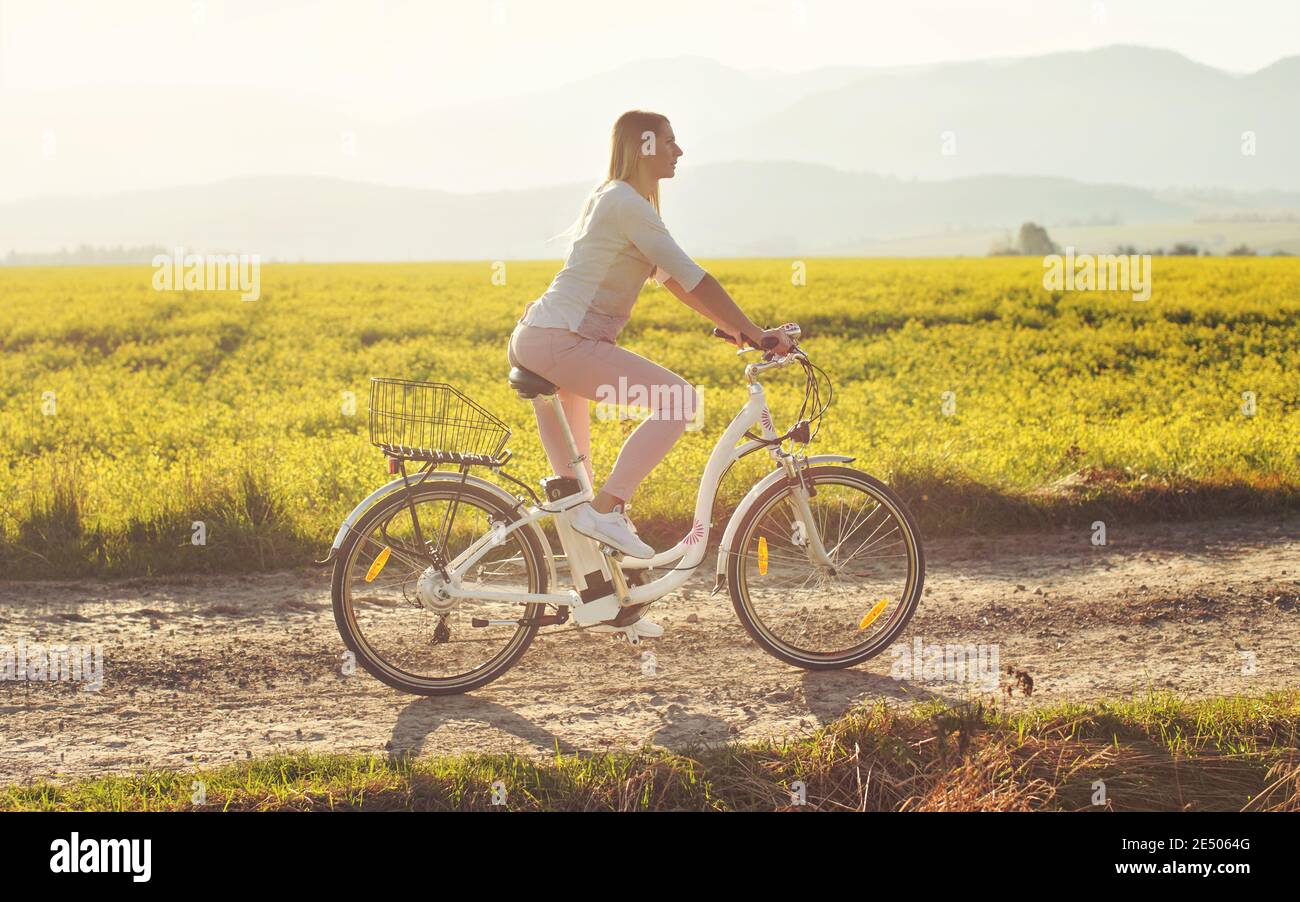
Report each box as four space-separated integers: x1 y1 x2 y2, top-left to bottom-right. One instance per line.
0 259 1300 577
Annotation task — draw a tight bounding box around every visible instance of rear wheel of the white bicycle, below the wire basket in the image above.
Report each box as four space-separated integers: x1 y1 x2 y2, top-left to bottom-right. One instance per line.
333 482 547 695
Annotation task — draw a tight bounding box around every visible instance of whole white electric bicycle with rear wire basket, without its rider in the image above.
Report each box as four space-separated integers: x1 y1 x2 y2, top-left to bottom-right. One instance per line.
330 324 924 695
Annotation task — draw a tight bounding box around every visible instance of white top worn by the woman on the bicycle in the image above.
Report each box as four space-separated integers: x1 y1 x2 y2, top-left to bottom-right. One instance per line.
520 179 705 342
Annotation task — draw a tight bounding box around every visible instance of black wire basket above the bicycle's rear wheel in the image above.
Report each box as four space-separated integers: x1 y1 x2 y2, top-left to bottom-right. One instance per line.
371 378 510 464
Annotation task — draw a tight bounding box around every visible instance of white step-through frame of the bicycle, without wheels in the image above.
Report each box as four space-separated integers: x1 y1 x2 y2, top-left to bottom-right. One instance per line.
445 380 780 625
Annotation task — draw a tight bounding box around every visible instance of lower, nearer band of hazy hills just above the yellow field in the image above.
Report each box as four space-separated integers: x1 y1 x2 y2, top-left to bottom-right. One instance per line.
10 162 1300 260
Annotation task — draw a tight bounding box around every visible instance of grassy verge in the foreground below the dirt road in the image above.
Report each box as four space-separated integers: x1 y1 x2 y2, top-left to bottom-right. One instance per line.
0 691 1300 811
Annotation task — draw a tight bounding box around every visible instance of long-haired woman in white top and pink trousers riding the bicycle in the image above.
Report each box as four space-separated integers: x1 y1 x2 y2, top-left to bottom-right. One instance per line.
508 110 790 579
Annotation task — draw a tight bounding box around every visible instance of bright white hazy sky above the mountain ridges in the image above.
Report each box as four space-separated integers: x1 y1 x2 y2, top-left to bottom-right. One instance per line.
0 0 1300 116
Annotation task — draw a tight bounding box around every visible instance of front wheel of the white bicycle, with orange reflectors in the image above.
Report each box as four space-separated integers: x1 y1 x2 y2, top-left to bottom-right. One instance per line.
727 467 926 671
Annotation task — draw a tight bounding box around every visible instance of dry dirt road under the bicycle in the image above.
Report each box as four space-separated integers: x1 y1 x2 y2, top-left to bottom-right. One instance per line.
0 517 1300 782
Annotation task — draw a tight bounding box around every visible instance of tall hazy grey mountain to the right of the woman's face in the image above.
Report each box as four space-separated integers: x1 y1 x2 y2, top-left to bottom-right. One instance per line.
709 47 1300 191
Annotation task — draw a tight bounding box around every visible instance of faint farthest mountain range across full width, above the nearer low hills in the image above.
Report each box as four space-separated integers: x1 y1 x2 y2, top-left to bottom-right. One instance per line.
0 47 1300 200
